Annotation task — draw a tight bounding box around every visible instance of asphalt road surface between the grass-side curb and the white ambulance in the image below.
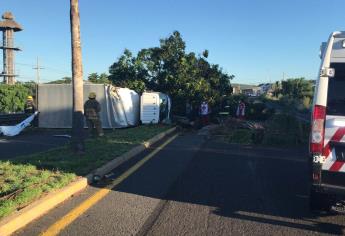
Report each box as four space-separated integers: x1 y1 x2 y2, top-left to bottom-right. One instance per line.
16 133 345 236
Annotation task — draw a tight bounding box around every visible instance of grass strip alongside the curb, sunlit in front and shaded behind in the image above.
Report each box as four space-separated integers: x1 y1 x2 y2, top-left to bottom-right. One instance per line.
0 125 171 219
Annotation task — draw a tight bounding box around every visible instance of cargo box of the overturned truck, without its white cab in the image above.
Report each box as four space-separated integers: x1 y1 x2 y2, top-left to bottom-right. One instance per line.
38 84 140 128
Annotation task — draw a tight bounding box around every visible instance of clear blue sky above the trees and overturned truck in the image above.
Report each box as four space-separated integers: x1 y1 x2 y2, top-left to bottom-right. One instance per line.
0 0 345 84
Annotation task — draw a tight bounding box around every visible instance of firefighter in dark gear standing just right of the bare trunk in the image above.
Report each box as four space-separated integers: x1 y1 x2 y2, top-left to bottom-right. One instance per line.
84 92 104 137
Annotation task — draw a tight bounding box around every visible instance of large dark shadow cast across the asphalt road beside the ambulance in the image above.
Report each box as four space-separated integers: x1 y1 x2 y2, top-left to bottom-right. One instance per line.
109 136 345 234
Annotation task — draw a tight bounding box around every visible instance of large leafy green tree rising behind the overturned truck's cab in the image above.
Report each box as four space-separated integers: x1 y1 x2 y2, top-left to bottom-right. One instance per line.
109 31 234 113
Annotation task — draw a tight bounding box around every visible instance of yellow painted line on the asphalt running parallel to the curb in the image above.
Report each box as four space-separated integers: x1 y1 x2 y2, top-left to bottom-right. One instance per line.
40 134 178 236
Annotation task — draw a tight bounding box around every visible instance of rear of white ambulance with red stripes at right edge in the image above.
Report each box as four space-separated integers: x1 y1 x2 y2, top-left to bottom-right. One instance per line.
309 32 345 210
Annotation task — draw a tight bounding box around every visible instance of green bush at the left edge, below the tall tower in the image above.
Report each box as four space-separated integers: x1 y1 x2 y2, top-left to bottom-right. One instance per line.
0 84 32 113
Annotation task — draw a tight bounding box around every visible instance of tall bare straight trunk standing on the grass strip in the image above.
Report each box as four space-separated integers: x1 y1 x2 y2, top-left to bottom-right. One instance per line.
70 0 84 154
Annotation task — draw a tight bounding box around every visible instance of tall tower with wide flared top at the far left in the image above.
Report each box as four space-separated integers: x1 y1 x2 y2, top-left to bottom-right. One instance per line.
0 12 23 85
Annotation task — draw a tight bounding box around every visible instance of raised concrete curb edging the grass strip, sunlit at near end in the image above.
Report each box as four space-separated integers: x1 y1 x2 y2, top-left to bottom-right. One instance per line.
0 127 176 236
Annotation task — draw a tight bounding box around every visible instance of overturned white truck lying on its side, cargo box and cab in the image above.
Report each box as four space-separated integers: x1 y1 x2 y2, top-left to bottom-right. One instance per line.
37 84 171 129
